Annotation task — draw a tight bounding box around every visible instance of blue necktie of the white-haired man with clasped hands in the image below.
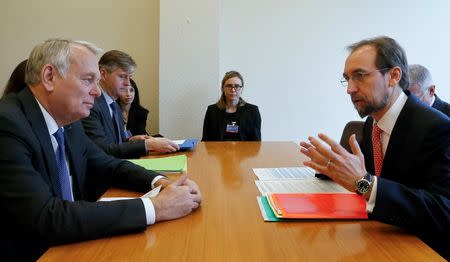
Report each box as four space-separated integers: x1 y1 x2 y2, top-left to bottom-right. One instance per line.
53 127 73 201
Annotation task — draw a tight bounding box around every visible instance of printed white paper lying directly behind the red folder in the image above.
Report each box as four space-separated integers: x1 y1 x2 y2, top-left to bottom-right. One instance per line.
255 178 349 194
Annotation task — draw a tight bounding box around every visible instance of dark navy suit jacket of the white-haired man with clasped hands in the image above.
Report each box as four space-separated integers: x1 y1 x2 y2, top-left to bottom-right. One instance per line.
0 88 157 261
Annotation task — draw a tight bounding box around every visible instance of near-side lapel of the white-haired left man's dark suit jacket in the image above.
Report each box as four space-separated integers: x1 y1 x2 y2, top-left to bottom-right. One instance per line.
18 88 62 197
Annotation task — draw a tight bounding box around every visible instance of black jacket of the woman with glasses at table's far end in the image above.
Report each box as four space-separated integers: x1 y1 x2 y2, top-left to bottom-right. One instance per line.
202 103 261 141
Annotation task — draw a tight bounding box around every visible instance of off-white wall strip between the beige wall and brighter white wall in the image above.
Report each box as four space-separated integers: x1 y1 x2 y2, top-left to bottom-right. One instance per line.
159 0 219 139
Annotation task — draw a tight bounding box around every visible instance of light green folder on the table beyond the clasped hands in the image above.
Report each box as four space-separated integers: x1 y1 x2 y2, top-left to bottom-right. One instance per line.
128 155 187 173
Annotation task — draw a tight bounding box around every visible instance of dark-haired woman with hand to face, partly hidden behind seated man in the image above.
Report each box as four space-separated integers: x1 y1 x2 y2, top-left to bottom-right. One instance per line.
118 79 148 137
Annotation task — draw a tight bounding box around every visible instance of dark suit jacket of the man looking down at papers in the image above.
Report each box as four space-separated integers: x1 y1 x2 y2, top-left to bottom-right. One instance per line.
81 94 147 159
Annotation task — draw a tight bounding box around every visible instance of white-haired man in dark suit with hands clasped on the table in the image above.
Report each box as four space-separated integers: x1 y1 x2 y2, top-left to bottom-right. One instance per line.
0 39 201 261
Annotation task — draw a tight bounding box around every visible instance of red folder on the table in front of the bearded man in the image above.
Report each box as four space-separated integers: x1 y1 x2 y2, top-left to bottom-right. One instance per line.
267 193 367 219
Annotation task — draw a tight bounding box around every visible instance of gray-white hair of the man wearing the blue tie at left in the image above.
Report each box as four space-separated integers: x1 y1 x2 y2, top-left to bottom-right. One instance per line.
25 38 101 86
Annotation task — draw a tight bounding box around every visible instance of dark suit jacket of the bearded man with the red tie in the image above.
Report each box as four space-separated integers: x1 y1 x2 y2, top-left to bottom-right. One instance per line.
361 92 450 259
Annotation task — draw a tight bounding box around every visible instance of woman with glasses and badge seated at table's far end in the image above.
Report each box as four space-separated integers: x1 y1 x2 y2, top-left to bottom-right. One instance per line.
202 71 261 141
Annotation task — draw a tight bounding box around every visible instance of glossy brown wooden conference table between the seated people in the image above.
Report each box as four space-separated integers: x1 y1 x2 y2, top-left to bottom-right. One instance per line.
40 142 443 261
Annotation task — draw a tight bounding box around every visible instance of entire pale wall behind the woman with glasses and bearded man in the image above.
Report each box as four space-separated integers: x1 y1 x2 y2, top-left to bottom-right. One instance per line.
160 0 450 141
